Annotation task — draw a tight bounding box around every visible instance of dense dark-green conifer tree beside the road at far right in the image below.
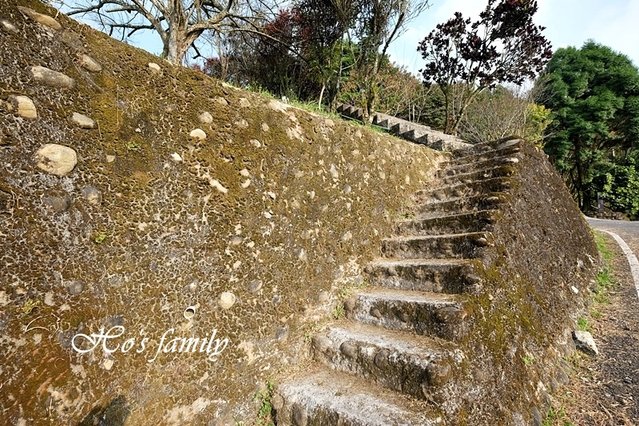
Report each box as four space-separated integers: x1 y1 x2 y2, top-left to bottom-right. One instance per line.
543 41 639 210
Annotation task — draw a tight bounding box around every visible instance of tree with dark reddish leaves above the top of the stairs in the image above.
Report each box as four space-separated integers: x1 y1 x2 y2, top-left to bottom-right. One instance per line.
417 0 552 134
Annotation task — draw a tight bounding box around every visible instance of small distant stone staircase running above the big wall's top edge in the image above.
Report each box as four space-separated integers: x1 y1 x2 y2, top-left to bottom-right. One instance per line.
337 104 472 152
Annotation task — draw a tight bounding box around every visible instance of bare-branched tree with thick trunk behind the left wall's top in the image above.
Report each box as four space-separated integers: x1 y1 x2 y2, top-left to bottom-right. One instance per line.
68 0 273 64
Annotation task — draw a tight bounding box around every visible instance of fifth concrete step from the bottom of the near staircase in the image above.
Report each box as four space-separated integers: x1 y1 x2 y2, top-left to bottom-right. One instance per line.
382 232 491 259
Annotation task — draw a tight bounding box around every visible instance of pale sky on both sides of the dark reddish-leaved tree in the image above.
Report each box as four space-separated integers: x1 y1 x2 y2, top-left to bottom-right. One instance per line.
389 0 639 73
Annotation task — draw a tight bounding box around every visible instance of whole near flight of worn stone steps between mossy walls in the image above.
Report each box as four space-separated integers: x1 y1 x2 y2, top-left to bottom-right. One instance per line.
274 139 520 426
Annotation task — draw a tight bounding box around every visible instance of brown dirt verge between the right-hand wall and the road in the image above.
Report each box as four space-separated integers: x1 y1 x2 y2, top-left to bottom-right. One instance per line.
544 236 639 426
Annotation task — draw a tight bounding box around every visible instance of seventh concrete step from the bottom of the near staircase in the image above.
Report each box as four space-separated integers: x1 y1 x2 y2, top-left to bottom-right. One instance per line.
416 192 506 219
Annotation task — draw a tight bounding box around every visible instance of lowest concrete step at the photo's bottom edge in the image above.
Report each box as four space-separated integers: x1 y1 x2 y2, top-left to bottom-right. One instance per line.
274 369 442 426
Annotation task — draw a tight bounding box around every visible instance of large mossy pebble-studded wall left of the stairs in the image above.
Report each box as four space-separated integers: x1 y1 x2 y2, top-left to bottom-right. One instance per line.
0 0 439 425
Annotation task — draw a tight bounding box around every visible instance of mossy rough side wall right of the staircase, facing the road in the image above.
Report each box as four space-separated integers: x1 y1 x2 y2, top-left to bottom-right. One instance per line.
462 143 598 425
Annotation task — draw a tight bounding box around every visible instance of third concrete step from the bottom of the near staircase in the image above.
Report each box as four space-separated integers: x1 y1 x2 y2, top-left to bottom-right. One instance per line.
344 289 466 340
